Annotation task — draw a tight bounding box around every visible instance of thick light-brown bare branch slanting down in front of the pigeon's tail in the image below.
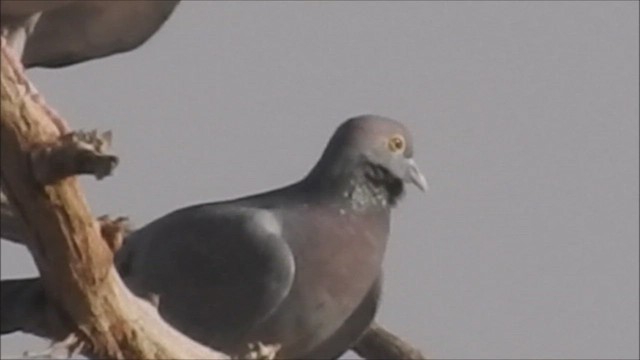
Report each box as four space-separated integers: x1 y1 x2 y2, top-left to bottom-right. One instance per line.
0 39 227 359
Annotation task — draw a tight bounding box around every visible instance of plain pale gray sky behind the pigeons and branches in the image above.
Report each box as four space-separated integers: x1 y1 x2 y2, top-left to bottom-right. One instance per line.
2 1 639 358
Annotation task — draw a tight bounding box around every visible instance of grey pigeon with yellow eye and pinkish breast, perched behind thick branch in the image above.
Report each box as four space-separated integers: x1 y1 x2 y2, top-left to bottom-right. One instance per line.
2 115 427 359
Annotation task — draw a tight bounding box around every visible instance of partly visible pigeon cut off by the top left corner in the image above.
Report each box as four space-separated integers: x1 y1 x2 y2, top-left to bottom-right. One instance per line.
0 0 179 68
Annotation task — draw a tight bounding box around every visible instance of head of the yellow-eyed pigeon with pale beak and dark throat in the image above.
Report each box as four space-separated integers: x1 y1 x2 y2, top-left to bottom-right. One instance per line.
307 115 428 206
